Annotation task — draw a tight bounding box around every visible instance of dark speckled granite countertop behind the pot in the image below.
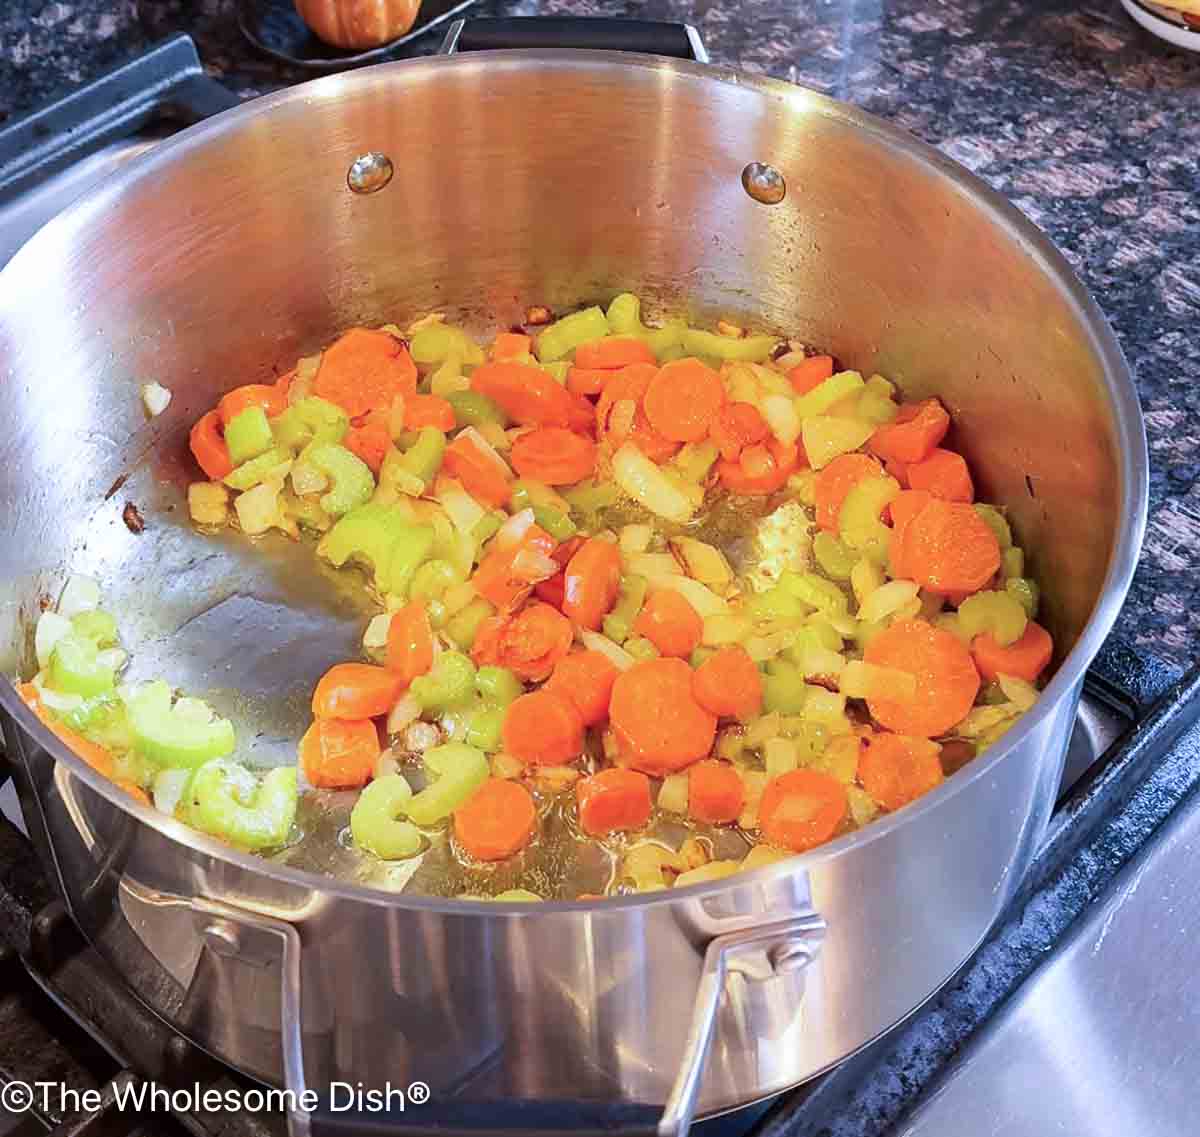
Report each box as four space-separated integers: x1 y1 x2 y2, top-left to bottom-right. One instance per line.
0 0 1200 664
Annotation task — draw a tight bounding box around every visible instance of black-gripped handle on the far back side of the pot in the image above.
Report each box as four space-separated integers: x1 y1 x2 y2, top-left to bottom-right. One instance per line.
438 16 708 64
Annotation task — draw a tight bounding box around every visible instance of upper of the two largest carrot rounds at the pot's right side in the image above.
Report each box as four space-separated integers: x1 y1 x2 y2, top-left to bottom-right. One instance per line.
900 498 1000 595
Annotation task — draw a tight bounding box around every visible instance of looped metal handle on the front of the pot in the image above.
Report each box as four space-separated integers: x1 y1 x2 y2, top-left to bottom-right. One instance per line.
188 898 826 1137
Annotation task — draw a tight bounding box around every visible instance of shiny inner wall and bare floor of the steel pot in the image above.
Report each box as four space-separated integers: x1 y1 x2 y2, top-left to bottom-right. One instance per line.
0 53 1145 882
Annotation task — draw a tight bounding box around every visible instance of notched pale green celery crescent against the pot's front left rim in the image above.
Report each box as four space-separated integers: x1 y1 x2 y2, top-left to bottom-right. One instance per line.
187 758 298 849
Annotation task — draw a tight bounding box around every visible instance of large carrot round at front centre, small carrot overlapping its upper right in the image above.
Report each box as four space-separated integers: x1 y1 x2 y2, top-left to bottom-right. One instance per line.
608 660 716 775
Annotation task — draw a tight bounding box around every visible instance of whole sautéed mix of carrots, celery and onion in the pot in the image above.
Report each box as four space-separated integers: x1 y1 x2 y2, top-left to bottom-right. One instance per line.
19 294 1052 900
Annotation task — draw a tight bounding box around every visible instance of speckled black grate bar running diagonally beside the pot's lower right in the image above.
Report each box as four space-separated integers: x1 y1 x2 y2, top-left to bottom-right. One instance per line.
748 666 1200 1137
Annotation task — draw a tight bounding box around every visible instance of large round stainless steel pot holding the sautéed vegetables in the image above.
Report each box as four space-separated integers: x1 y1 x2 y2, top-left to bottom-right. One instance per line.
0 24 1146 1133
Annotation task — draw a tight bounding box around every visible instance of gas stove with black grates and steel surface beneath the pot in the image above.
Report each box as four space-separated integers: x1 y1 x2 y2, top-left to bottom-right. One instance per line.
0 36 1200 1137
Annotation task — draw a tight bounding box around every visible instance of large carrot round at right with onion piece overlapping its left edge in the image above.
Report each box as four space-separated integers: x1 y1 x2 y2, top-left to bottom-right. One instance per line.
863 620 979 739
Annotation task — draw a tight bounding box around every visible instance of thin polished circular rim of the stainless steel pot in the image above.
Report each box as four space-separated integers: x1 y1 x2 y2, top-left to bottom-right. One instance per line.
0 49 1150 916
